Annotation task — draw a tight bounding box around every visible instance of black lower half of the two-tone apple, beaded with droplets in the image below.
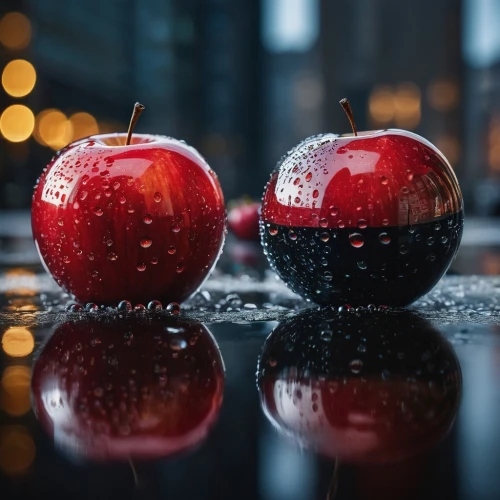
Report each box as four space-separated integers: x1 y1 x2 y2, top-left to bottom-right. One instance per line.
261 211 463 307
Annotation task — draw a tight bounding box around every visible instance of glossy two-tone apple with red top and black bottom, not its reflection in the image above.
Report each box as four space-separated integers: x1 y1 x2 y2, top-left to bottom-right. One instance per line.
261 99 463 306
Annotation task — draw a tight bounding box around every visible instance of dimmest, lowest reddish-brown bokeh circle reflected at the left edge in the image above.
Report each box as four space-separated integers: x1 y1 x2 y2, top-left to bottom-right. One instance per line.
0 425 36 475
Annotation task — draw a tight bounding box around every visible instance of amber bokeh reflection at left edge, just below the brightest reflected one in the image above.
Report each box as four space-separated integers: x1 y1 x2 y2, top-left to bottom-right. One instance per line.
0 365 31 417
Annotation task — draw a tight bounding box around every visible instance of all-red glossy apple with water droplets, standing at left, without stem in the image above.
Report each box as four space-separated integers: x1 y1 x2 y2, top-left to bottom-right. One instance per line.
32 134 226 305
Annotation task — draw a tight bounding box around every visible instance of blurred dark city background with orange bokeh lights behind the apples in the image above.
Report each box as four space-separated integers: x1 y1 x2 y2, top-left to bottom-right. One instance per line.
0 0 500 273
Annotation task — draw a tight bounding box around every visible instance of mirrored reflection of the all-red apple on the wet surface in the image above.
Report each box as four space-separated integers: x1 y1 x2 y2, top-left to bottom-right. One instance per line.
32 318 224 461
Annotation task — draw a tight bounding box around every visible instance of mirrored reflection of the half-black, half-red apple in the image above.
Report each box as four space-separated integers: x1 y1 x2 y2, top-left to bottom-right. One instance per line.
257 310 462 464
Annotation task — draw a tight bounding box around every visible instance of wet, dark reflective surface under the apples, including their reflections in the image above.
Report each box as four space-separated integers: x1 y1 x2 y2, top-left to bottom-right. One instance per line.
0 262 500 500
